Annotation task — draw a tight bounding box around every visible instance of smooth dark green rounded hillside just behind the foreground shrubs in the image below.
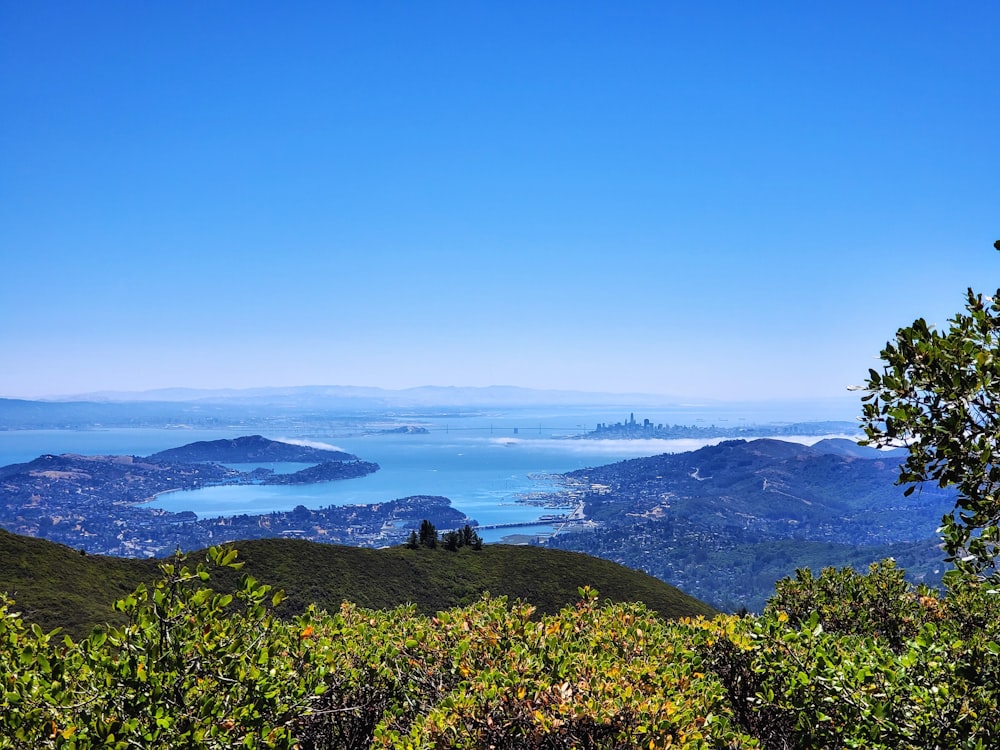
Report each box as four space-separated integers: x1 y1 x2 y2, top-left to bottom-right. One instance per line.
0 529 715 636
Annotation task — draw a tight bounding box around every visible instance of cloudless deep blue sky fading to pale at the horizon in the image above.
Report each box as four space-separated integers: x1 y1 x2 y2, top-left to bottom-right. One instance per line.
0 0 1000 399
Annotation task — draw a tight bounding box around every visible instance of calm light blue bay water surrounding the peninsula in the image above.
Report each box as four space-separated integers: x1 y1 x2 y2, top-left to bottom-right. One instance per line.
0 412 856 541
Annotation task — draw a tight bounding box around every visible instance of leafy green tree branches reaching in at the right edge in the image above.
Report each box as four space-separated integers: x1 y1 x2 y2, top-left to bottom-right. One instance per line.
862 240 1000 575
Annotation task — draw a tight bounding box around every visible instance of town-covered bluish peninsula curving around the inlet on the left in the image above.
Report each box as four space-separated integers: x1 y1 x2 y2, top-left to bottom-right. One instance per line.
0 435 474 557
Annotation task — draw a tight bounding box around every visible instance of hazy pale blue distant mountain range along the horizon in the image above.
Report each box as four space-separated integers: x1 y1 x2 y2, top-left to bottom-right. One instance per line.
0 386 858 430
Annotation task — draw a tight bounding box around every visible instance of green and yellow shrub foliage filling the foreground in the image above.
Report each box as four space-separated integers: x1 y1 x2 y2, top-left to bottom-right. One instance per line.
0 548 1000 750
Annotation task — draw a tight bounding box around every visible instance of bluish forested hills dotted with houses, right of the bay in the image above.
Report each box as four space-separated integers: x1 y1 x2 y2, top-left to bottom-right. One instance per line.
549 439 954 611
